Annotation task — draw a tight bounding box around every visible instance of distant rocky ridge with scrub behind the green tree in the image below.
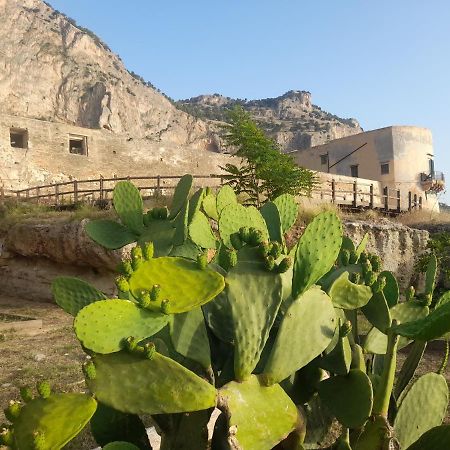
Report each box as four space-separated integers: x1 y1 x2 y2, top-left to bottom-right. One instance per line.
178 91 363 152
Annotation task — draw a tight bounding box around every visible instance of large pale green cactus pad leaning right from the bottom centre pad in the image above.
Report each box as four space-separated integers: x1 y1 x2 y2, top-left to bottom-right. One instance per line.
263 286 338 384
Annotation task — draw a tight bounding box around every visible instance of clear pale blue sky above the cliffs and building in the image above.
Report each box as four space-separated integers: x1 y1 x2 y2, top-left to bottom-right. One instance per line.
49 0 450 203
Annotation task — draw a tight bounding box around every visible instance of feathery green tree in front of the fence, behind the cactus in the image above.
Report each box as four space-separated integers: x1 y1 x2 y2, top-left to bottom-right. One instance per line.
222 106 317 206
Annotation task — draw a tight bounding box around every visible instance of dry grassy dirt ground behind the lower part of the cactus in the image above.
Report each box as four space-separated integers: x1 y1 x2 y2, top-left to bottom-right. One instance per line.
0 295 450 450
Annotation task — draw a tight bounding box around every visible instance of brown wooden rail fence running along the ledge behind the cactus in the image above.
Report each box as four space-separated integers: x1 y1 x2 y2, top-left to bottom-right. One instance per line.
0 175 422 213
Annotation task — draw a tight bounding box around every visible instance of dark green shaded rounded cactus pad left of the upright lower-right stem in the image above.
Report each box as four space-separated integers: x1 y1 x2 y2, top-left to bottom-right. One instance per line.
318 369 373 428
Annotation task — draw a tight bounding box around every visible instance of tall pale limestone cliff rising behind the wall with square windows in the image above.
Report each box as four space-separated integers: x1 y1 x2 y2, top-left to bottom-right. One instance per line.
0 0 207 145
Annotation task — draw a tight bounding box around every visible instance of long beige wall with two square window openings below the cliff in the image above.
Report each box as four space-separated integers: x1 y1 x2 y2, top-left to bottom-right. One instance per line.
0 115 231 190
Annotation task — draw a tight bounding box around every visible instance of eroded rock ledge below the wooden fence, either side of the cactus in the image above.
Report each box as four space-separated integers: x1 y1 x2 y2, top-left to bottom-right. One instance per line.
0 220 428 302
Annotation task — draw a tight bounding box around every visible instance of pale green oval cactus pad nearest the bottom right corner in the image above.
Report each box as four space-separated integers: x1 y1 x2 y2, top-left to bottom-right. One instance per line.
394 373 448 448
